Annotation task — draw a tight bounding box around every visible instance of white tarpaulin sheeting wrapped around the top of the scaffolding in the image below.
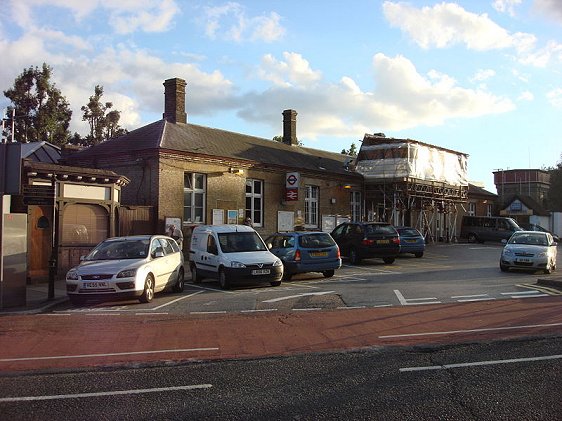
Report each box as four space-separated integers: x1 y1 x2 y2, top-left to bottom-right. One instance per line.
356 142 468 186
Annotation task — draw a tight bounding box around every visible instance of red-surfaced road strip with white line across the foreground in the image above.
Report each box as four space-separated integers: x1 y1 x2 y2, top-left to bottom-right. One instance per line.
0 297 562 373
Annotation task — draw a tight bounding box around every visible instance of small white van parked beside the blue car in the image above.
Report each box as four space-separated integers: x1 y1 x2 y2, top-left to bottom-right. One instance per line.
189 225 283 289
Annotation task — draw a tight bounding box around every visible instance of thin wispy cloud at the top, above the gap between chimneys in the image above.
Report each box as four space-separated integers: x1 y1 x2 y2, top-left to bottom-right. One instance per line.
200 2 285 42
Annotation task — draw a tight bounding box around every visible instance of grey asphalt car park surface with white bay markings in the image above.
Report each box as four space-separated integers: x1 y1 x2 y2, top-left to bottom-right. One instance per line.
52 243 562 315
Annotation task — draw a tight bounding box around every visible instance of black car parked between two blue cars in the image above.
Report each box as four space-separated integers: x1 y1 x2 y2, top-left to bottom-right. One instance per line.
331 222 400 265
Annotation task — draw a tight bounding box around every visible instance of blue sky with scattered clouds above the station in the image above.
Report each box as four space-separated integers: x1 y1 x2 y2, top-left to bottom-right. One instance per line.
0 0 562 193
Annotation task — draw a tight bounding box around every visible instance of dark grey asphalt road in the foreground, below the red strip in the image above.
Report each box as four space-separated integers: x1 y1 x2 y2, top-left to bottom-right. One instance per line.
0 337 562 421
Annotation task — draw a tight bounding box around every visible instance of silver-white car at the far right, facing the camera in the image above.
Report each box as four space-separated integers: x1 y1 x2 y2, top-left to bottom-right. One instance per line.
500 231 557 273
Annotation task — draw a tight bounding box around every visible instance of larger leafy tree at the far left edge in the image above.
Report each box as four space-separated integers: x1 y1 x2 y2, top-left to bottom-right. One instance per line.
4 63 72 145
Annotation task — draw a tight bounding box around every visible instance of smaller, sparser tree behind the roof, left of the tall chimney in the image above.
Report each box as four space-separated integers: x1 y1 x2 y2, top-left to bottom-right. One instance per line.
80 85 127 145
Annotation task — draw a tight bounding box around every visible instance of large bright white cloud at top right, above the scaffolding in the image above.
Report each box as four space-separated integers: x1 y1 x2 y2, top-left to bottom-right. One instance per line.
383 1 535 51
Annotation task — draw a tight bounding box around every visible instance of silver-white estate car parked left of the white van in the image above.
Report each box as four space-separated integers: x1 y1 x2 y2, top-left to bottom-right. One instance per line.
66 235 184 304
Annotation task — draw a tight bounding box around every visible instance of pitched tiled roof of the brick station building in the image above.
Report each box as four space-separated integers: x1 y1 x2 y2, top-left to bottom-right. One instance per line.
67 120 359 177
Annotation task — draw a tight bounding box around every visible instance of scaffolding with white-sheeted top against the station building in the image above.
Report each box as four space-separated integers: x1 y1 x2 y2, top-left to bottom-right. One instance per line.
356 134 468 243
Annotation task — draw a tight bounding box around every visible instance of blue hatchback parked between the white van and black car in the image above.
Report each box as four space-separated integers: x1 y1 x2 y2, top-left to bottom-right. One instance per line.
265 231 341 280
